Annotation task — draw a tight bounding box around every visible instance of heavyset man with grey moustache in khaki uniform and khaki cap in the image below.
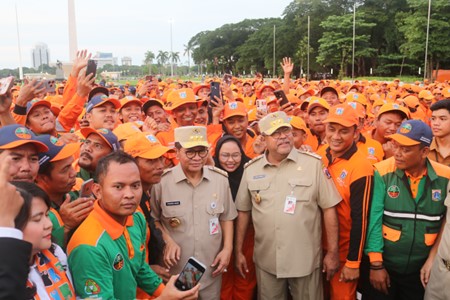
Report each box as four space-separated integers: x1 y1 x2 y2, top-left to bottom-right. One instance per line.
235 112 341 300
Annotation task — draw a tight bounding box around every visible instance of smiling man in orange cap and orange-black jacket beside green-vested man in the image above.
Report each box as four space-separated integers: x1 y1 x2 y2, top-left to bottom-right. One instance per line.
318 104 373 300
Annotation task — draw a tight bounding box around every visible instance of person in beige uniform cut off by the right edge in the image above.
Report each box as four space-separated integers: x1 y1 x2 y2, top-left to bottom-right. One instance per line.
420 182 450 300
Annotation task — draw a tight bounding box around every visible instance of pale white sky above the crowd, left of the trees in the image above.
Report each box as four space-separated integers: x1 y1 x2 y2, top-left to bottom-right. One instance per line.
0 0 293 69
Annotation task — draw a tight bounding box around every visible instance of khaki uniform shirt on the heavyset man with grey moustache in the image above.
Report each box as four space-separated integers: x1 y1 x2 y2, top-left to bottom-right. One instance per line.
236 149 341 278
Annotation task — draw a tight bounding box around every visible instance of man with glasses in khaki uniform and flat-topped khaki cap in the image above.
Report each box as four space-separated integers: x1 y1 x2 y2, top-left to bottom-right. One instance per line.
150 126 237 300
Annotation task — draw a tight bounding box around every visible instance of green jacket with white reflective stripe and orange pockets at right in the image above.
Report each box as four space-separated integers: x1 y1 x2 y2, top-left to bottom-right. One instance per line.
365 158 450 274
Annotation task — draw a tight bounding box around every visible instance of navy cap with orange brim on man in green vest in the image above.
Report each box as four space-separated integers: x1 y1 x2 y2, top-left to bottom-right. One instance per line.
387 120 433 146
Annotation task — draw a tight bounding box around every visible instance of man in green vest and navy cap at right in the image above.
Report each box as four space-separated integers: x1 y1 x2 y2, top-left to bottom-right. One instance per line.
365 120 450 300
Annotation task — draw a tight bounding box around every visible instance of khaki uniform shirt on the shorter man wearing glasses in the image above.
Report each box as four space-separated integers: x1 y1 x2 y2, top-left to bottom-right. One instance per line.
150 164 237 289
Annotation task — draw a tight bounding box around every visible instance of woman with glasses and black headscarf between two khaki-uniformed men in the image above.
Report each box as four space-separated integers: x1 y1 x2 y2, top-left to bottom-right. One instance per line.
214 135 256 299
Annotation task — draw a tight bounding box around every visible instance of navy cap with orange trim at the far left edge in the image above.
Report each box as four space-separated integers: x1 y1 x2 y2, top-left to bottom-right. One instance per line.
0 124 48 152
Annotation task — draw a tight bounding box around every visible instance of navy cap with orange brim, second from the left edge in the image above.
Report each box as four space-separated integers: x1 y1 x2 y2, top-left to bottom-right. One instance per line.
36 134 80 166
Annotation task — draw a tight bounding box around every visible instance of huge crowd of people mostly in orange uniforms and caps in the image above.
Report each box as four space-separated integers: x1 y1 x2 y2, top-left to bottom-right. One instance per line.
0 50 450 300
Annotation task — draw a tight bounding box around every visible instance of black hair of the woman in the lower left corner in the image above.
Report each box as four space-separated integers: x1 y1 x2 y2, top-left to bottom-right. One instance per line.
11 181 50 230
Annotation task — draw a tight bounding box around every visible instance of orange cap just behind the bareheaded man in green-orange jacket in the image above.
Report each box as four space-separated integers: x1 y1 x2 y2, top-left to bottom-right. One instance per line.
124 132 171 159
